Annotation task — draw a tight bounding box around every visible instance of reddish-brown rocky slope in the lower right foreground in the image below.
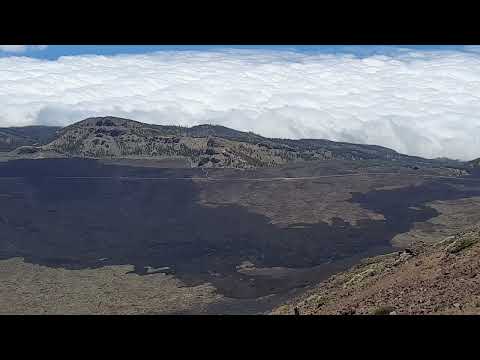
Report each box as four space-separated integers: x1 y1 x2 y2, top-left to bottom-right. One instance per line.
273 226 480 315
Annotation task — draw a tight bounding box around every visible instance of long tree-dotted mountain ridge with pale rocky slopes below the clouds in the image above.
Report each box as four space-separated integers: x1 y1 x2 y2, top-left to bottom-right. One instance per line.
0 116 472 168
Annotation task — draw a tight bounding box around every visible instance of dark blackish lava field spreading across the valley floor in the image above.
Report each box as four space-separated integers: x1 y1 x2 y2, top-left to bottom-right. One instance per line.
0 159 480 312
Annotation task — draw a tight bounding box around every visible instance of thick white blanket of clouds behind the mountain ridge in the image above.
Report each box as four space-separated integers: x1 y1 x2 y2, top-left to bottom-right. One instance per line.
0 50 480 159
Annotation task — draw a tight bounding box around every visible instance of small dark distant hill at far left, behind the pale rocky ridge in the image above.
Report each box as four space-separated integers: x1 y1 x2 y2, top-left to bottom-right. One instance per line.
0 126 61 151
